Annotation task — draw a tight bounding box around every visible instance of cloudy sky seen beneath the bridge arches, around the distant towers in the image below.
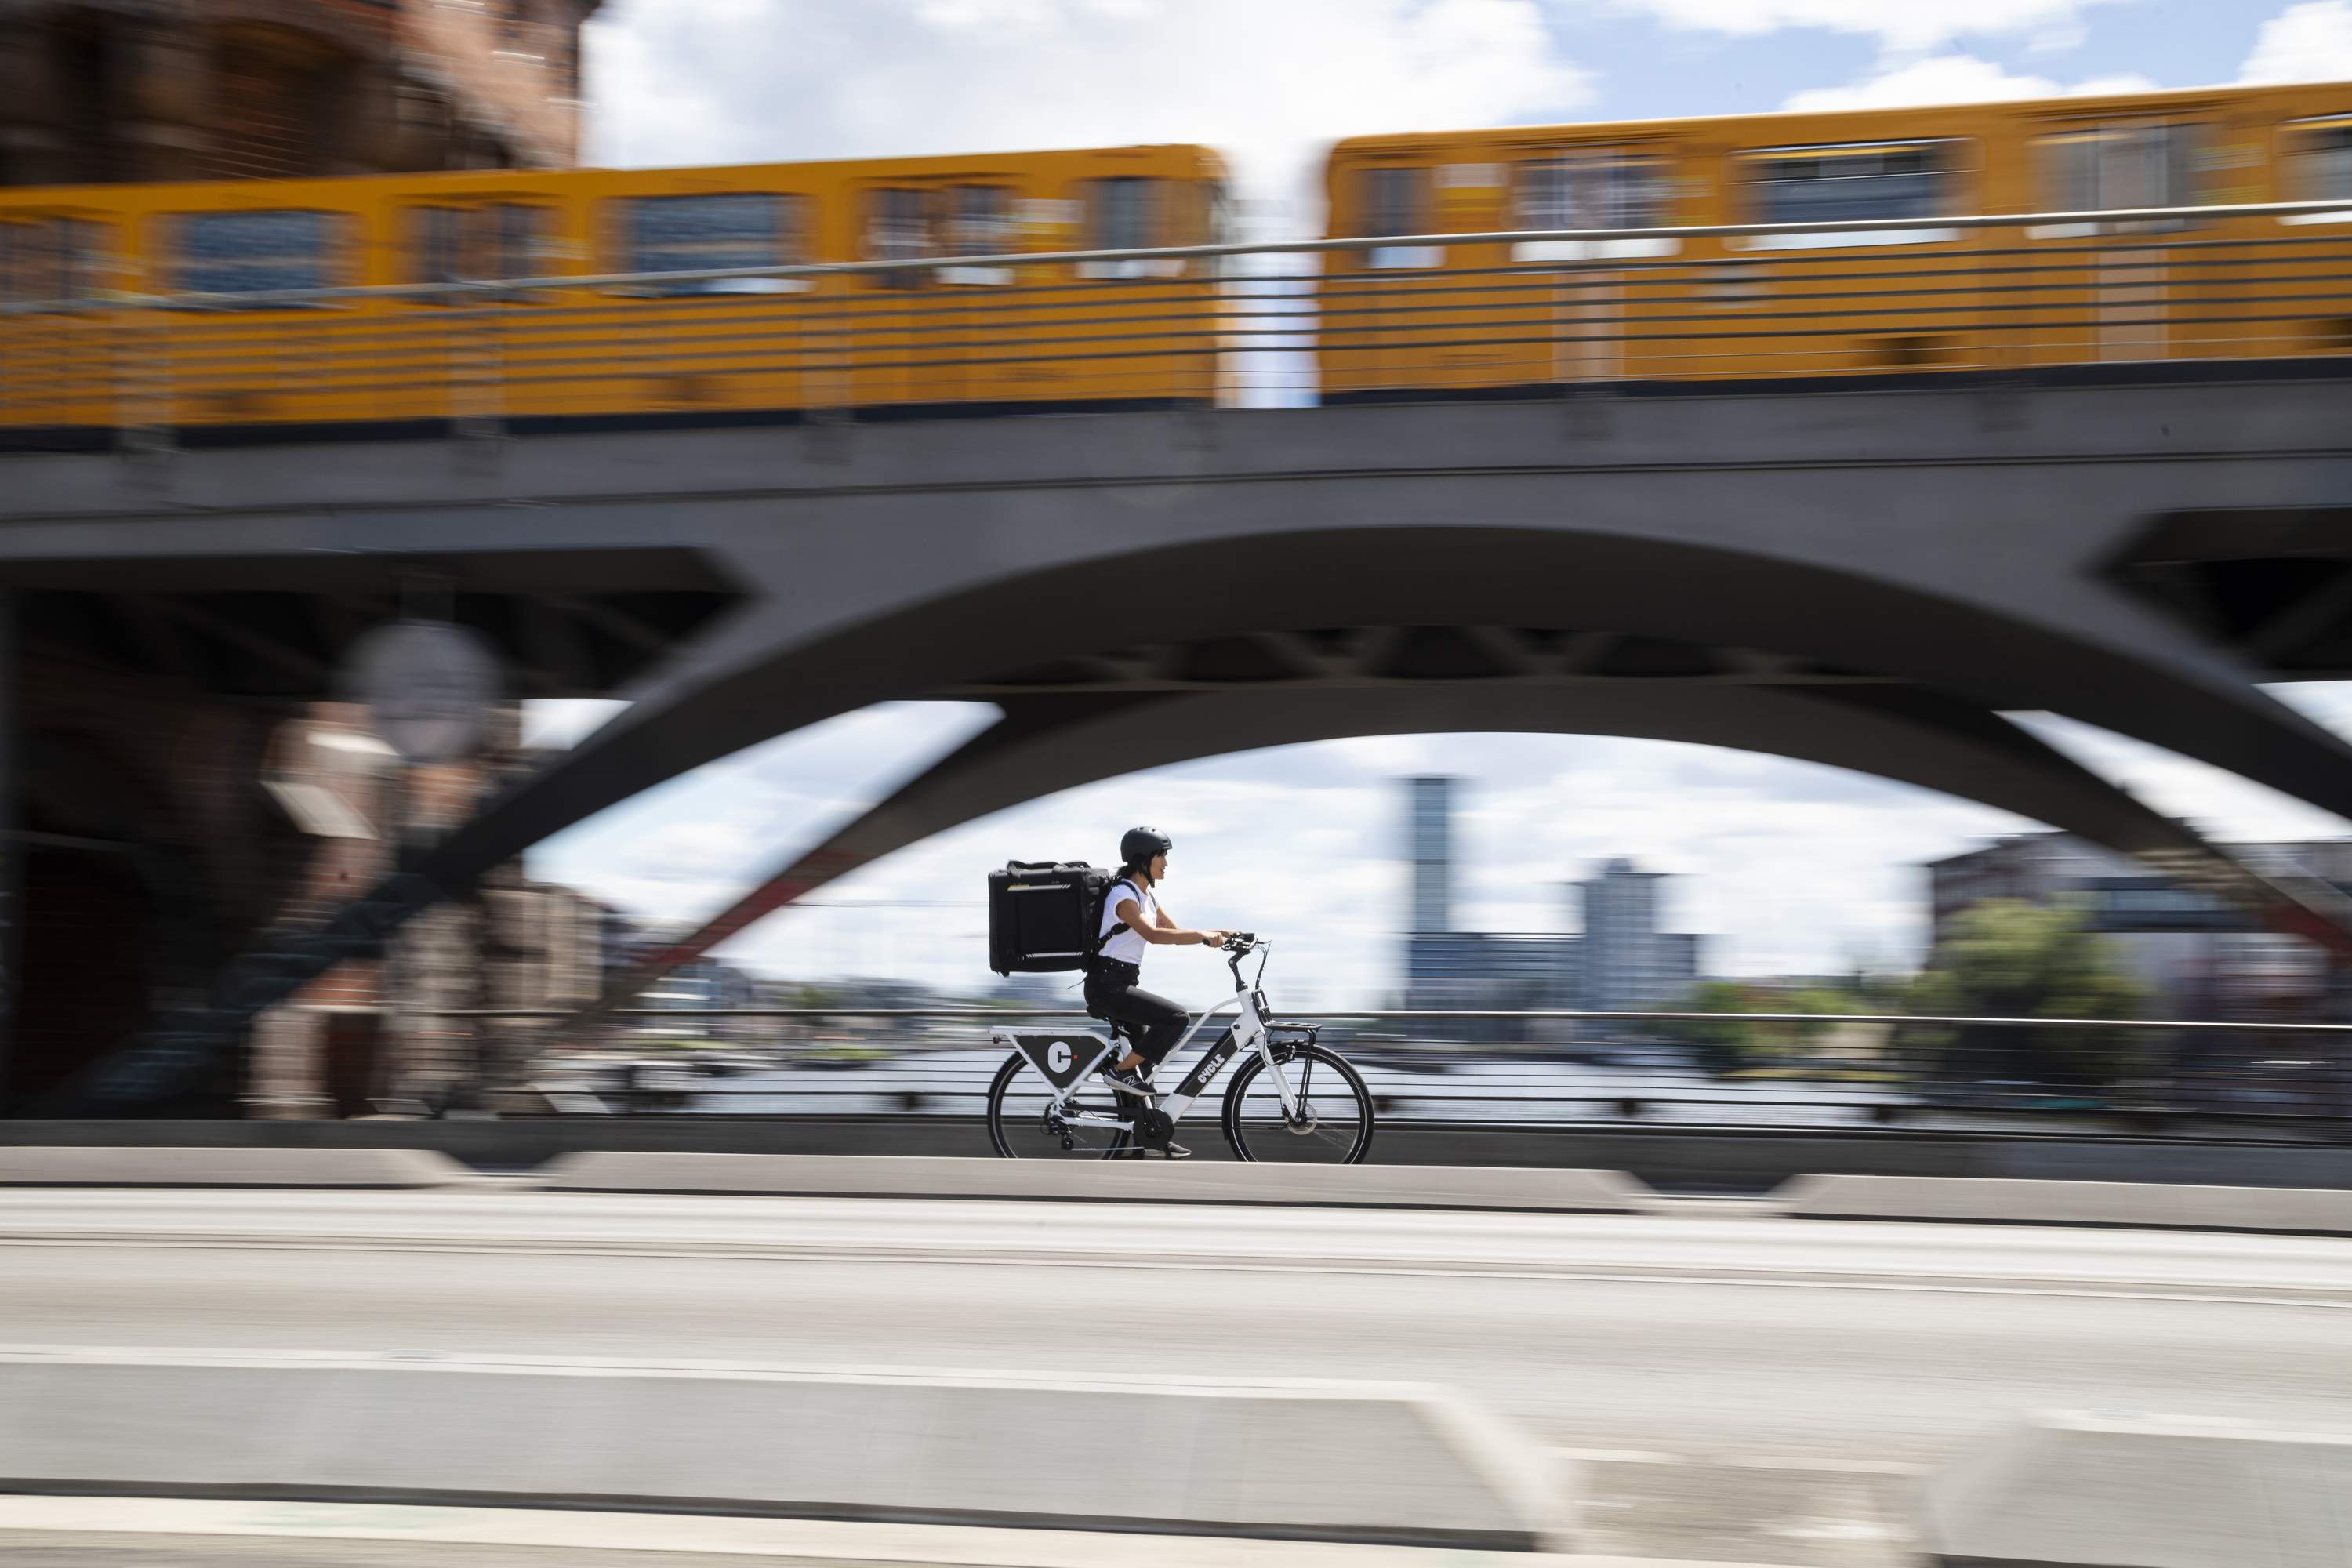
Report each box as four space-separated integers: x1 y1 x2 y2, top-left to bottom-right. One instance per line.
527 682 2352 1006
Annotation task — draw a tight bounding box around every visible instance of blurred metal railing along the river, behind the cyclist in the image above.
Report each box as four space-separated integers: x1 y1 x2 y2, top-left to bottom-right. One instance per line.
343 1006 2352 1140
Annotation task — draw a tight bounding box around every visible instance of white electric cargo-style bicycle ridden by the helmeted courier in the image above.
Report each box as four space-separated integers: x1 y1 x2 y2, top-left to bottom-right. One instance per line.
988 931 1371 1166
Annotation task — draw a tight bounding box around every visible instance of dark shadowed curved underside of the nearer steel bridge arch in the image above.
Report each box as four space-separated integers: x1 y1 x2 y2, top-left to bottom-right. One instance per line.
416 524 2352 891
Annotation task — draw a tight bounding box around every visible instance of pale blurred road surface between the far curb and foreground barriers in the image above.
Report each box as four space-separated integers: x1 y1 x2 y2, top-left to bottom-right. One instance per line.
0 1189 2352 1563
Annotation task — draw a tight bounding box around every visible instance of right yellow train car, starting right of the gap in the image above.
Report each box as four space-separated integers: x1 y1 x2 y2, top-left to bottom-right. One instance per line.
1317 85 2352 402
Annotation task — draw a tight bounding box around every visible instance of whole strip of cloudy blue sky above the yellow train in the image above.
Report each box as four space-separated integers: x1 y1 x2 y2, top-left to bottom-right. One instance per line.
588 0 2352 216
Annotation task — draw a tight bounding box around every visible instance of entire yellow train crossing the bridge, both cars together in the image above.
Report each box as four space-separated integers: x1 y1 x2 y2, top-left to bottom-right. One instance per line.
0 74 2352 445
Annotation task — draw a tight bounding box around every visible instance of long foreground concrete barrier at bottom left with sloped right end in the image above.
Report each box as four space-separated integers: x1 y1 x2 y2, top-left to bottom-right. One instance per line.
0 1347 1562 1552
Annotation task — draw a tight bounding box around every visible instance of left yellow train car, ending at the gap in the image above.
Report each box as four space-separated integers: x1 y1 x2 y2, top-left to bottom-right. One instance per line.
0 146 1228 437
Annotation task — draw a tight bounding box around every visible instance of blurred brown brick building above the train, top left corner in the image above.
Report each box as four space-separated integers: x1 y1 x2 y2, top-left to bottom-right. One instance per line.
0 0 600 186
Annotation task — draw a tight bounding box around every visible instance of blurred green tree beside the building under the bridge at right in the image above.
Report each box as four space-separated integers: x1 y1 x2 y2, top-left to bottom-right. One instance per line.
1907 898 2147 1088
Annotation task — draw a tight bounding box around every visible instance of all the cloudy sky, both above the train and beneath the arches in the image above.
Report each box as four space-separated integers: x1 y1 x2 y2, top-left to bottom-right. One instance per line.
532 0 2352 1004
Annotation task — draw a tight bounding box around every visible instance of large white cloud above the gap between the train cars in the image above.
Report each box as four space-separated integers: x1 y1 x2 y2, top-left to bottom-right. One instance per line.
588 0 1588 210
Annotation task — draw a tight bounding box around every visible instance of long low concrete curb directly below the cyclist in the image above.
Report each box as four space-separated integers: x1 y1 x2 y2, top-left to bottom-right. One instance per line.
539 1152 1651 1213
